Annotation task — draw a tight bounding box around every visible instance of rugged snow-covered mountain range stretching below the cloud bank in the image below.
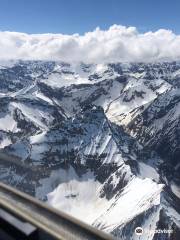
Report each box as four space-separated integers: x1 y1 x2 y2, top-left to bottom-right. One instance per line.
0 61 180 240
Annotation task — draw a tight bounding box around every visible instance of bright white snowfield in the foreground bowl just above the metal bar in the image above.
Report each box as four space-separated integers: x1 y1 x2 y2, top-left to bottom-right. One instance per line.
48 172 163 232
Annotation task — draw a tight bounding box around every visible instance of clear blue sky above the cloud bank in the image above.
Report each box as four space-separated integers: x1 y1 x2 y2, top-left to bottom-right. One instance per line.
0 0 180 34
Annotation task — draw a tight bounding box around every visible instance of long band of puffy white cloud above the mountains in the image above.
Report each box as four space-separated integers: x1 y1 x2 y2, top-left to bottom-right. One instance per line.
0 25 180 62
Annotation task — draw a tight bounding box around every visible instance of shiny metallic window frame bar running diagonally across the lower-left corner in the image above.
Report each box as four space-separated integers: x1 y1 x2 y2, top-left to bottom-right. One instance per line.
0 183 114 240
